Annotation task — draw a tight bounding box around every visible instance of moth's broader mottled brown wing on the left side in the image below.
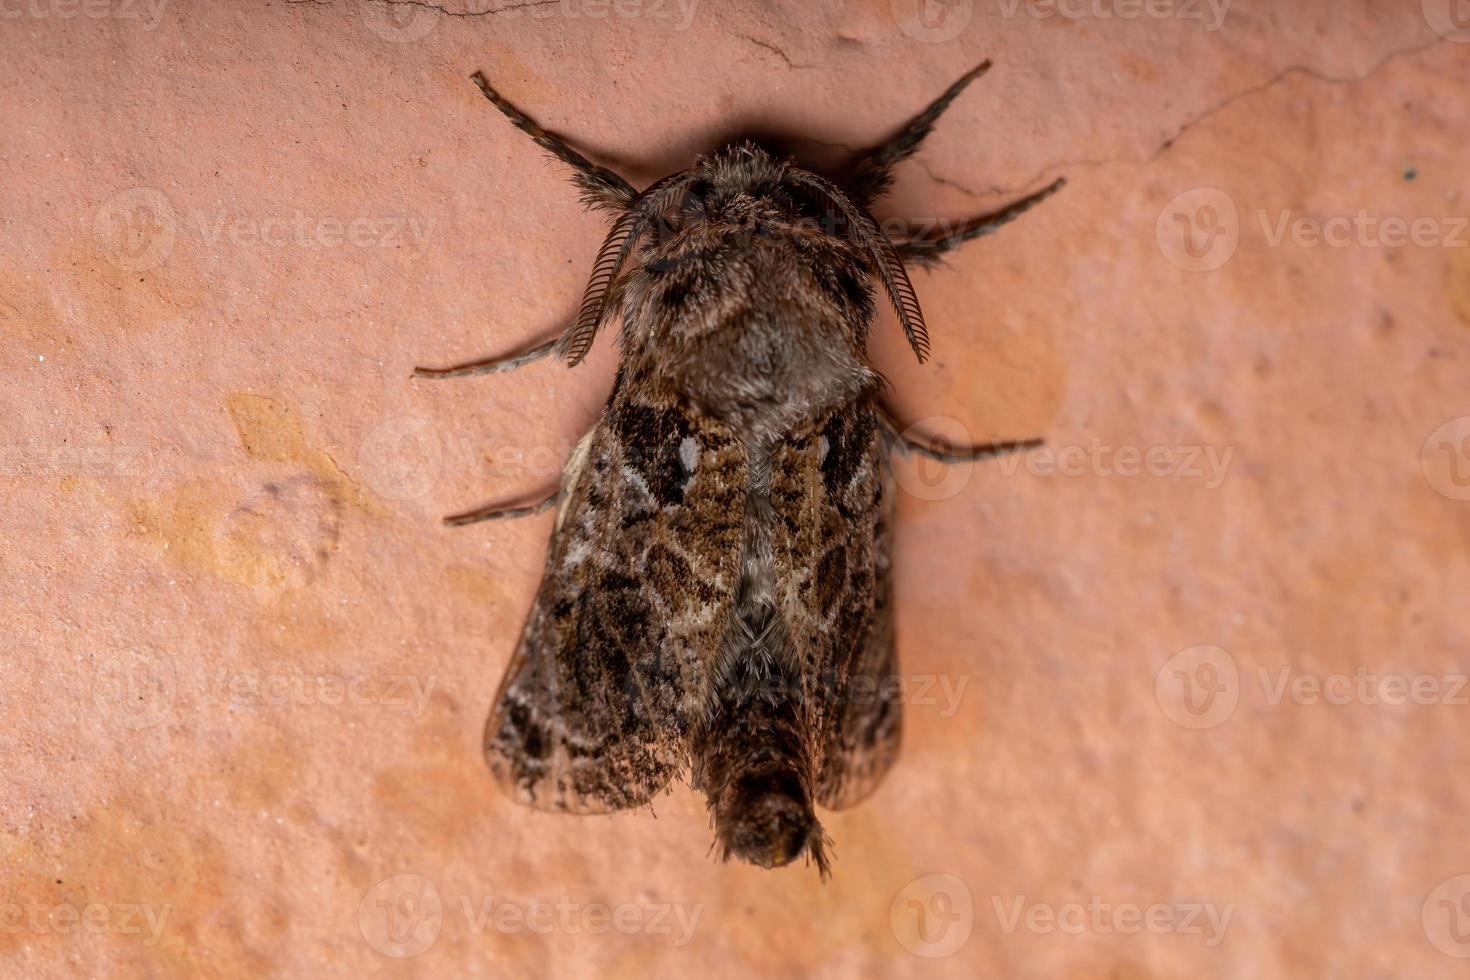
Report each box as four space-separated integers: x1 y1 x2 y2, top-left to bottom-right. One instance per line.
485 367 747 813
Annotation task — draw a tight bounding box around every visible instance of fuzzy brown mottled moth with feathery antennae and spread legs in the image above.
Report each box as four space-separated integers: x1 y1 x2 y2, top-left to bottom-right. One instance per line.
415 62 1063 877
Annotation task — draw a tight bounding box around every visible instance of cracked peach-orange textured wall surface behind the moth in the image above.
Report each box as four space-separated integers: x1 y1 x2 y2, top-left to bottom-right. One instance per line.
0 0 1470 977
